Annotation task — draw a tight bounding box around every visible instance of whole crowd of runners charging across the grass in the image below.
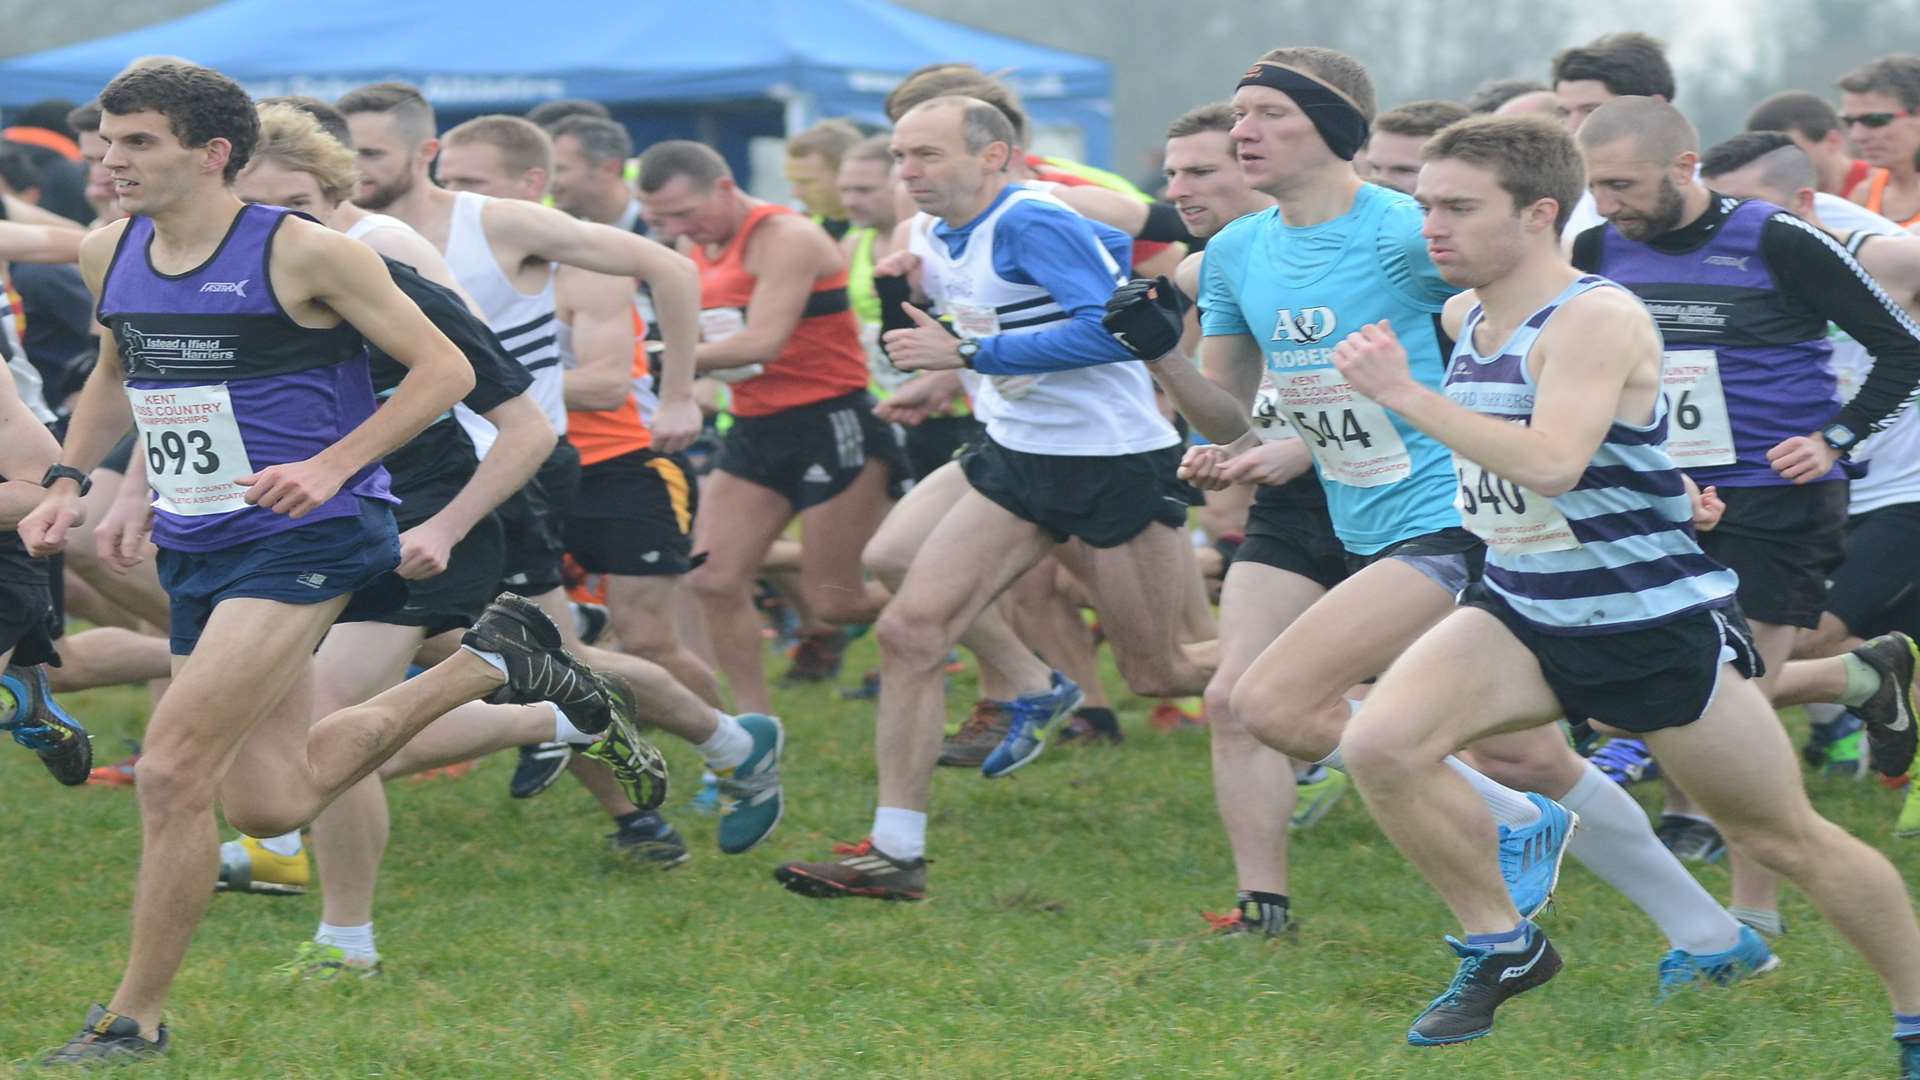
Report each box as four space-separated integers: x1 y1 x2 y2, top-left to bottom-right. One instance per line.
0 33 1920 1078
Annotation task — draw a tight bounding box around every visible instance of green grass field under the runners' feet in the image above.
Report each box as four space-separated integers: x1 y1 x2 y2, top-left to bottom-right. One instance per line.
0 630 1914 1080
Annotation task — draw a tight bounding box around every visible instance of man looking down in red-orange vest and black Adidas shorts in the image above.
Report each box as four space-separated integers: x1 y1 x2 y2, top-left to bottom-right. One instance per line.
639 140 904 711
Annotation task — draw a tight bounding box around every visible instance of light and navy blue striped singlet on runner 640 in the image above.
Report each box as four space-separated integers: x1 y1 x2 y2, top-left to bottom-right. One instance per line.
1446 275 1740 634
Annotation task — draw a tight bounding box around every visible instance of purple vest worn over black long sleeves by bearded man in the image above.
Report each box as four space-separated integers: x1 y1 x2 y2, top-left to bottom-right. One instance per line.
1594 200 1843 488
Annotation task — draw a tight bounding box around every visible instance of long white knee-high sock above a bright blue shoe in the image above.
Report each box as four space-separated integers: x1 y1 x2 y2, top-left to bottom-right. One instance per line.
1559 765 1740 955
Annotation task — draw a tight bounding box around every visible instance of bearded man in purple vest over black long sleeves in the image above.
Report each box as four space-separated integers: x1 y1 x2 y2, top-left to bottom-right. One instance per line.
1572 98 1920 932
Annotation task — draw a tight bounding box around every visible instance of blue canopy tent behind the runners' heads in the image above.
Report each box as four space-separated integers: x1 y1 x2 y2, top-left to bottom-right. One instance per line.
0 0 1112 171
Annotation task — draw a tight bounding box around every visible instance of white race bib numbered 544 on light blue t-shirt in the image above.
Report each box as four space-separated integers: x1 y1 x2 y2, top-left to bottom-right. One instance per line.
1273 369 1413 488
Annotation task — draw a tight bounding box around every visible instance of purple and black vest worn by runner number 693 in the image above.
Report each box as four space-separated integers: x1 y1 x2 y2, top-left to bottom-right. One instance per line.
98 206 396 552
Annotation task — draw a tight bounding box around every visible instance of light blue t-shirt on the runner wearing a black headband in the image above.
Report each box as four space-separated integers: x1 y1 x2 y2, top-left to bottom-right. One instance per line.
1200 184 1459 555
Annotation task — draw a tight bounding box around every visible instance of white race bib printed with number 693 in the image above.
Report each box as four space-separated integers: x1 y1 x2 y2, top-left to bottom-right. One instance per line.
127 384 253 517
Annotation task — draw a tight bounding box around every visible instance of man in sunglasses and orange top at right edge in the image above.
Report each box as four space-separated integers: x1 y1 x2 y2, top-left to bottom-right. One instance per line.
1839 56 1920 229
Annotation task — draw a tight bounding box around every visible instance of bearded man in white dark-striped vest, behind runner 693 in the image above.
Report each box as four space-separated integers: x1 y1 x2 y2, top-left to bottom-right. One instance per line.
340 83 785 867
